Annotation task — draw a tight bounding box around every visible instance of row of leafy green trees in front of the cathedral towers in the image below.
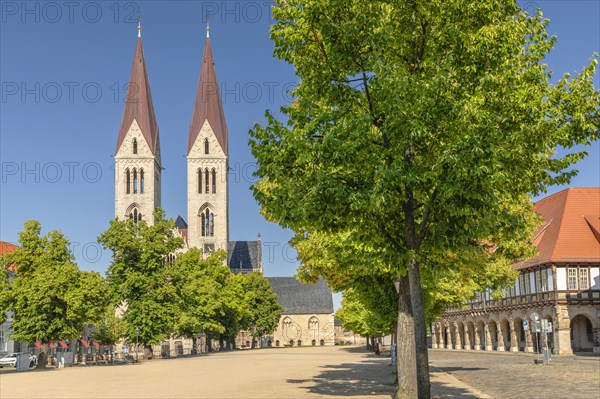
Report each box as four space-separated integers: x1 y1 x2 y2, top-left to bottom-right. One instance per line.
0 209 283 366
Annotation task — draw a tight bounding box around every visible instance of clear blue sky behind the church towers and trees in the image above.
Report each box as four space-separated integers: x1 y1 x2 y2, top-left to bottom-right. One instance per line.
0 0 600 304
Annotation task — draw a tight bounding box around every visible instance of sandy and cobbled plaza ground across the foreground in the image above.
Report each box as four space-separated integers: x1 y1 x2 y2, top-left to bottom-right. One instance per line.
0 347 600 399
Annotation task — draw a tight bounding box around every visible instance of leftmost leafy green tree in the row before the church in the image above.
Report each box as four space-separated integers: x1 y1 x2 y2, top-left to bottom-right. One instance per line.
2 221 108 367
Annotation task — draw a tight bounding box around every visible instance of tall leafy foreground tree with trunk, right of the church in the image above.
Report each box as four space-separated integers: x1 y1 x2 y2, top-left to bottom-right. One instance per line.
251 0 599 398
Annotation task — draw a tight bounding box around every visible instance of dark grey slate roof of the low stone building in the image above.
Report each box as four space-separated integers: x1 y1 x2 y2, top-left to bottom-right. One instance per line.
267 277 333 314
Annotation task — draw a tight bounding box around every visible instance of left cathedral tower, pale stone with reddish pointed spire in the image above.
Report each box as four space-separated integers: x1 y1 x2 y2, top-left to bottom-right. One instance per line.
115 26 162 224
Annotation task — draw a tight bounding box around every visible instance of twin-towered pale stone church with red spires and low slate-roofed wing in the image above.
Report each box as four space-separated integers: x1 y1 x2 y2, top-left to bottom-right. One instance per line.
115 26 334 356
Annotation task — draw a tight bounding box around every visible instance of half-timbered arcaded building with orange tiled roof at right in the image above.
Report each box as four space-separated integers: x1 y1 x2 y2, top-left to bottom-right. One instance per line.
431 188 600 355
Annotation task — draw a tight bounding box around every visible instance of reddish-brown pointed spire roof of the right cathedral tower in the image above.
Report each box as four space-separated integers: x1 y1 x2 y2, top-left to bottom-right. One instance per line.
188 38 227 155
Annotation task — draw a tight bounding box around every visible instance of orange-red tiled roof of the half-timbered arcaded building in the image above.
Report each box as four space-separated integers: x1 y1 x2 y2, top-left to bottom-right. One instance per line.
515 188 600 269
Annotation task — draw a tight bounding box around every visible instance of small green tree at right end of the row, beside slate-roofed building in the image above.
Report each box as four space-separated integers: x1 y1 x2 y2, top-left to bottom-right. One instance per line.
244 273 283 348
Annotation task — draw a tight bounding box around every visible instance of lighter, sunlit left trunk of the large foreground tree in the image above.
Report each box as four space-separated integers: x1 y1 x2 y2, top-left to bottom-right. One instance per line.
395 277 419 399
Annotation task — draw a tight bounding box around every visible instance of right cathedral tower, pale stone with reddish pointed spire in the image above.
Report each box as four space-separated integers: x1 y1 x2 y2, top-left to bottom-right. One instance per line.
187 28 229 253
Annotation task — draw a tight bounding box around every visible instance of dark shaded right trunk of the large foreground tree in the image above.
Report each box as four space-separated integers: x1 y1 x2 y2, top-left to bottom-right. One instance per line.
408 257 431 399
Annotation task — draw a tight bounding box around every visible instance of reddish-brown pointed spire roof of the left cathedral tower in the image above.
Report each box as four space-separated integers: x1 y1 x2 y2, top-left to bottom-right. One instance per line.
116 37 158 154
